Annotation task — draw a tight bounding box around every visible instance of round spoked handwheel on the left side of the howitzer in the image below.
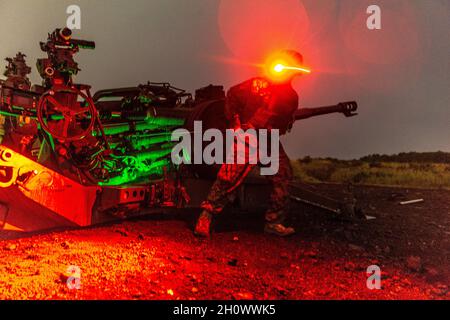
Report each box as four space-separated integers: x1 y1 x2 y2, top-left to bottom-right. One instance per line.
37 87 97 141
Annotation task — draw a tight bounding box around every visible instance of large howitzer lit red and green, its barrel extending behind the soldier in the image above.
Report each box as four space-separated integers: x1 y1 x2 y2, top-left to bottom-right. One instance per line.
0 29 357 236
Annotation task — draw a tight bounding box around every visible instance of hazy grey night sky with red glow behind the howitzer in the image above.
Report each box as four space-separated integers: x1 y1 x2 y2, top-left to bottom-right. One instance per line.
0 0 450 158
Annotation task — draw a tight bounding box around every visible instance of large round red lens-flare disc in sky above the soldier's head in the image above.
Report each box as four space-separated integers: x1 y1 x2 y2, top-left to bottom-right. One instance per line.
219 0 310 61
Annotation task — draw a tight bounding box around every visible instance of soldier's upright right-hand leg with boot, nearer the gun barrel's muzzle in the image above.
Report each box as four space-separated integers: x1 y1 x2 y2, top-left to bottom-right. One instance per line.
265 144 295 236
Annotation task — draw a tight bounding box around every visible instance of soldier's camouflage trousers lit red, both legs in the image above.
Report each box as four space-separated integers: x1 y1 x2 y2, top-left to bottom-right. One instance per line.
202 143 293 223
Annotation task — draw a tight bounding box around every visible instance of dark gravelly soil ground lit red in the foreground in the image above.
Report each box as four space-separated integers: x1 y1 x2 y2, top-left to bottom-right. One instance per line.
0 185 450 300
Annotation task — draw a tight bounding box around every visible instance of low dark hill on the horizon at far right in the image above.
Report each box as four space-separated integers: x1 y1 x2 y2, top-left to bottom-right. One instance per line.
360 151 450 164
